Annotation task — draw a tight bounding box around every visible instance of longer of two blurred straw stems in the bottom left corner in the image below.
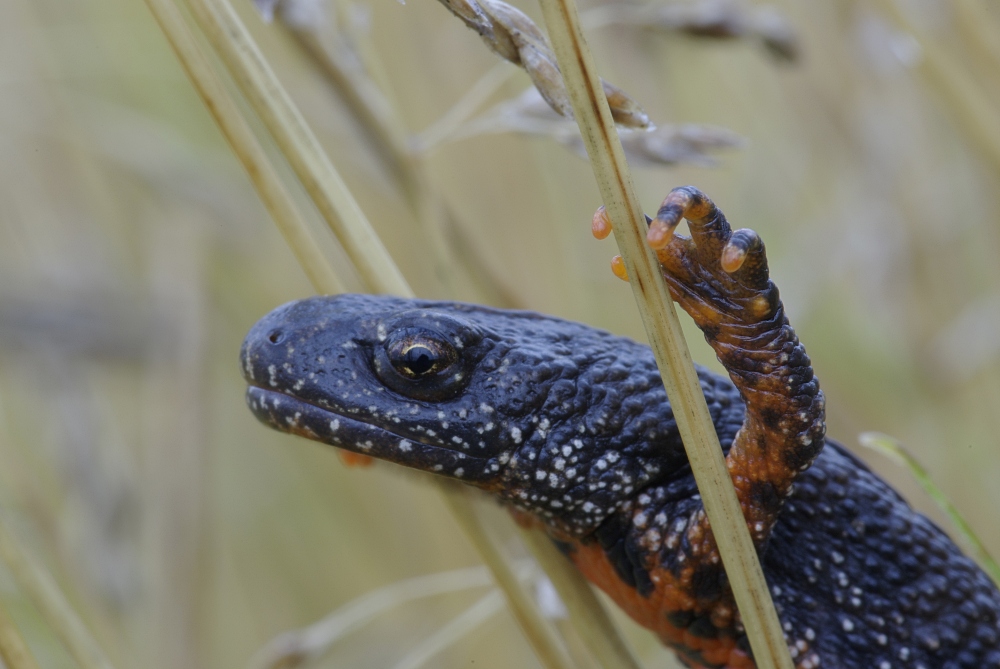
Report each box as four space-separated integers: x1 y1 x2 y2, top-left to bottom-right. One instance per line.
0 518 113 669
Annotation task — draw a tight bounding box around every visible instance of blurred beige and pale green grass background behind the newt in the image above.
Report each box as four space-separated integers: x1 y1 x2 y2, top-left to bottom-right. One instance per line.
0 0 1000 669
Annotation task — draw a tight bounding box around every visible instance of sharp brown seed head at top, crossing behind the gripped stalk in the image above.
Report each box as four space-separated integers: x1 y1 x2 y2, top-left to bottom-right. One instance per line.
441 0 650 128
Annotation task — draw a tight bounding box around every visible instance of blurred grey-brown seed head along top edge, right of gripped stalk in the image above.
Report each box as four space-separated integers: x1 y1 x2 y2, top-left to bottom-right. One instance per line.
581 0 801 61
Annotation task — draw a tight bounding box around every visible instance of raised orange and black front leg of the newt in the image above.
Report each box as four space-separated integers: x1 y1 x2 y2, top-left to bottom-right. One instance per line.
648 186 826 552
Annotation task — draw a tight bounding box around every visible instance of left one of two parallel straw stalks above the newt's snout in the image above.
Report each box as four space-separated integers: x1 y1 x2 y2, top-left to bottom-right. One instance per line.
146 0 344 293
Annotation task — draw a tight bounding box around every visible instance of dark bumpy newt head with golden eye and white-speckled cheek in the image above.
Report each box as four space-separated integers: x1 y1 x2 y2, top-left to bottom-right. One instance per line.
241 295 704 536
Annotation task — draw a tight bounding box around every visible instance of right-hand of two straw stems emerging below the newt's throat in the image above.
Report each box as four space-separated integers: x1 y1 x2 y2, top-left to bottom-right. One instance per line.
521 529 642 669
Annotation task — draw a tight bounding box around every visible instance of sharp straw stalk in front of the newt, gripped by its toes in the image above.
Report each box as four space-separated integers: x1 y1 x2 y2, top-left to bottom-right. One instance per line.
541 0 793 669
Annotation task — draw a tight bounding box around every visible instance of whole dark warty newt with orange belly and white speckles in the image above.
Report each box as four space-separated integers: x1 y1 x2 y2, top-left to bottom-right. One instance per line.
241 187 1000 669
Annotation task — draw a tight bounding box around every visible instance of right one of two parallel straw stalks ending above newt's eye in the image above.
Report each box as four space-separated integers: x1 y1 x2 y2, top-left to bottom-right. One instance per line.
189 0 412 296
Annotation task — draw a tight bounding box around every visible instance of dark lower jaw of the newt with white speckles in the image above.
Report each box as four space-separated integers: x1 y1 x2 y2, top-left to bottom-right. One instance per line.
246 385 496 482
